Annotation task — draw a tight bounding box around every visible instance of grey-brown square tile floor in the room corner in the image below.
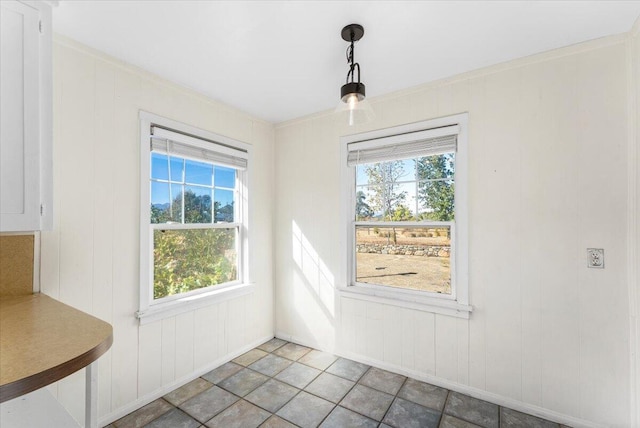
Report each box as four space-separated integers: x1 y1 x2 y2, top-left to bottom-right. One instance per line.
109 339 560 428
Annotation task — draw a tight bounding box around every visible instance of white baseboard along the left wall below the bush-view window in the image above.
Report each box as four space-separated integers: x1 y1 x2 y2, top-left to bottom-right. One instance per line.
98 335 273 427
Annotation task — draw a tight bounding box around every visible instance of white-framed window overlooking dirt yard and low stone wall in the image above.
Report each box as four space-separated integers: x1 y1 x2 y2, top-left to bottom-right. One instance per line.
343 115 471 317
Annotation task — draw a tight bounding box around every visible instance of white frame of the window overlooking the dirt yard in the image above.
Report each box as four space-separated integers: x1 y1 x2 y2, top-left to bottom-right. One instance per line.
338 113 472 318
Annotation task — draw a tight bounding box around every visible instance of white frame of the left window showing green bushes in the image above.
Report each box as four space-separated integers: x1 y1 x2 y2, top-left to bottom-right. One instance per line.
136 111 254 324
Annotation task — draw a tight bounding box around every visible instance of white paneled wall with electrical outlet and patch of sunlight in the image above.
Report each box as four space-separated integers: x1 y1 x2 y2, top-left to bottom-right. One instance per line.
275 36 631 427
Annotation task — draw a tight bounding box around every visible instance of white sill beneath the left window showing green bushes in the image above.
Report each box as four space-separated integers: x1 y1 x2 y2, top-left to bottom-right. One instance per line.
136 284 255 325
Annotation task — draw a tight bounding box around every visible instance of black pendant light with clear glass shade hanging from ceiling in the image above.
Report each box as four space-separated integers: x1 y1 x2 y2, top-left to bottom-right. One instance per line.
336 24 374 126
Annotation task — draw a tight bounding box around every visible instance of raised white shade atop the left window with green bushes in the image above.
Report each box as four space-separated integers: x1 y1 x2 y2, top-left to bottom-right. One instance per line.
151 126 248 170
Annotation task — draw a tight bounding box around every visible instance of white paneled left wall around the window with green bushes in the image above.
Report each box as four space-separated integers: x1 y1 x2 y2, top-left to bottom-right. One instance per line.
41 37 274 423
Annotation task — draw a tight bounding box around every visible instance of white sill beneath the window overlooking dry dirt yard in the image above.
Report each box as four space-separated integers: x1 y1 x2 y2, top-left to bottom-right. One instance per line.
339 286 473 319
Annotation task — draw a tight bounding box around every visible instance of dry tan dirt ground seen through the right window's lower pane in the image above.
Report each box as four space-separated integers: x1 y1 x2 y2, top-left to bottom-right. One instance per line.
356 253 451 294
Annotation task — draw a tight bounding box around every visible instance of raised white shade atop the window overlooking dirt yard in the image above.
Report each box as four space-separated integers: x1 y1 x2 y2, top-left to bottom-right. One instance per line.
347 125 459 166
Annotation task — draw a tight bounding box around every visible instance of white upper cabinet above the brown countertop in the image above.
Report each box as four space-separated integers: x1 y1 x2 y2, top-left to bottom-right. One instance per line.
0 1 53 232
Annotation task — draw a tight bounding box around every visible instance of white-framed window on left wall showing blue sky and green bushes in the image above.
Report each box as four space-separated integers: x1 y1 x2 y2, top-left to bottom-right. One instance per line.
138 113 249 319
